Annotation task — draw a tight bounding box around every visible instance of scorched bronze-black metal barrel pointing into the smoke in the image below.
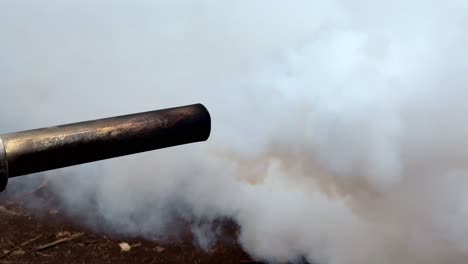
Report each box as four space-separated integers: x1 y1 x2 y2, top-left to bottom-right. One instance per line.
0 104 211 191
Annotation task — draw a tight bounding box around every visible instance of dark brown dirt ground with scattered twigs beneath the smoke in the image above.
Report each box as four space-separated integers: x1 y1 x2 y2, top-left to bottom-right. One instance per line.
0 182 260 264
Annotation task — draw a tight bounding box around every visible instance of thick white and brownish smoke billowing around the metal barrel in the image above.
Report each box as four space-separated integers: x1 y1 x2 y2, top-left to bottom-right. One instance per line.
0 0 468 264
